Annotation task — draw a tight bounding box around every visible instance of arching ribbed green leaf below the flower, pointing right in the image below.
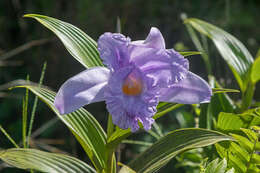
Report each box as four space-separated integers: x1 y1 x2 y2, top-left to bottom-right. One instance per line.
128 128 232 173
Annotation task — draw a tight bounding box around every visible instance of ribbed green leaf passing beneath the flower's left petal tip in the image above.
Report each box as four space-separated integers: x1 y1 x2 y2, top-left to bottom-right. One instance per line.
13 85 106 170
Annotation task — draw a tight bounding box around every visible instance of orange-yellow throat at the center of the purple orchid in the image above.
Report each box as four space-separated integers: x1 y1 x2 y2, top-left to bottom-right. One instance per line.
122 74 143 96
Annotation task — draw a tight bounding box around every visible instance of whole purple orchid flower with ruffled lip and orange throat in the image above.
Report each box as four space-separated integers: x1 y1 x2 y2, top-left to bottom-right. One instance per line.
54 27 212 132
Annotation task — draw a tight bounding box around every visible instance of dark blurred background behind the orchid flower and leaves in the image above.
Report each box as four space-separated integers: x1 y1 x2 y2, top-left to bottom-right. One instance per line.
0 0 260 172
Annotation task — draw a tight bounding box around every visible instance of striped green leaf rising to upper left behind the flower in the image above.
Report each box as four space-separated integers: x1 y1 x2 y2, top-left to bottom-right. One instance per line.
24 14 102 68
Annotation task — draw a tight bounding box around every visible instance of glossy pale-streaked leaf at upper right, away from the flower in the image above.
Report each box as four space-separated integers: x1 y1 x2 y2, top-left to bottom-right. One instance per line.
184 18 254 92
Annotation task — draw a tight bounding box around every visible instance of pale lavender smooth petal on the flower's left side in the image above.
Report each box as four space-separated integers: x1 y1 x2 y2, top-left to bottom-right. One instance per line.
54 67 110 114
